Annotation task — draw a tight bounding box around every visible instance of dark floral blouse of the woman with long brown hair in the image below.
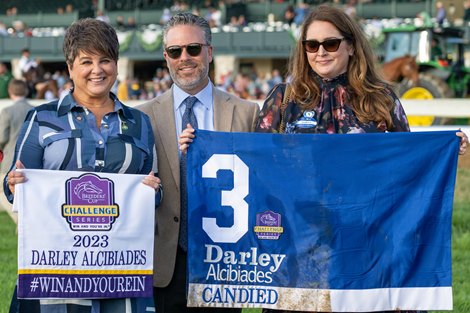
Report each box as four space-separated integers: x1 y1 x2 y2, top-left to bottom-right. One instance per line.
256 74 410 134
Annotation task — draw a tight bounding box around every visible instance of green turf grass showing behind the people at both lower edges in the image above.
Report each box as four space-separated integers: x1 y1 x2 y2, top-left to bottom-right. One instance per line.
0 168 470 313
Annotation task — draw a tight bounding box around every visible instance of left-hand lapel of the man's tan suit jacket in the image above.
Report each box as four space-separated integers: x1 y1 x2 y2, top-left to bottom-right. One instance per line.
154 88 180 187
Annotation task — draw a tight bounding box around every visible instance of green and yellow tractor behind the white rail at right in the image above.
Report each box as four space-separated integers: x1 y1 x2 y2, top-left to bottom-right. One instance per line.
382 25 470 126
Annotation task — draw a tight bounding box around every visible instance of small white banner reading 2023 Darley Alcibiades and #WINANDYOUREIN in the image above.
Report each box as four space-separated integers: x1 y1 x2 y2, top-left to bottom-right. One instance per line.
13 169 155 299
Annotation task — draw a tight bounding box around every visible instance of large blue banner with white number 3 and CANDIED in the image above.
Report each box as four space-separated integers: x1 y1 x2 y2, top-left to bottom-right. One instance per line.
187 130 459 312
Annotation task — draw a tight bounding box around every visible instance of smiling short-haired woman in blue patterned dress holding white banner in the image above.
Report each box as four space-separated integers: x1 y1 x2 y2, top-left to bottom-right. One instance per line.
4 18 161 313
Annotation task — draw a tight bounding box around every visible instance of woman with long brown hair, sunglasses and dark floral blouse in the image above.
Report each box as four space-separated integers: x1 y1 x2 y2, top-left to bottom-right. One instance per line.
256 5 468 313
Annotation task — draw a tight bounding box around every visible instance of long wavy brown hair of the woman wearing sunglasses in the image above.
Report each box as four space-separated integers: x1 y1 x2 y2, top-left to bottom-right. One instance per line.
289 5 394 128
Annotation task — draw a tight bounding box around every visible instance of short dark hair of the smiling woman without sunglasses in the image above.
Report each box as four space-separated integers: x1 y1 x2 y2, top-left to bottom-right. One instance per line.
63 18 119 66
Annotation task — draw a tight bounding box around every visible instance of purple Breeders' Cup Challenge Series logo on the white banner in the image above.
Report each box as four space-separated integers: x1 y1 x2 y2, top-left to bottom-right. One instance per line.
62 173 119 231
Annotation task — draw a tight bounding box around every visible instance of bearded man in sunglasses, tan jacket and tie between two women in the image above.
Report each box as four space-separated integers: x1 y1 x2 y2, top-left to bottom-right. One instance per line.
138 13 259 313
